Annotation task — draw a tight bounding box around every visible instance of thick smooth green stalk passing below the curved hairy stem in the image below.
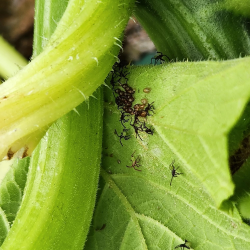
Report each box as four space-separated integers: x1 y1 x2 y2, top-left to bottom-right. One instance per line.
0 90 103 250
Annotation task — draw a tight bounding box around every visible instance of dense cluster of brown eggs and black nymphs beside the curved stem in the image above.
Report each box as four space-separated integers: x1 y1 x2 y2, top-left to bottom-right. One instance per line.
110 64 154 146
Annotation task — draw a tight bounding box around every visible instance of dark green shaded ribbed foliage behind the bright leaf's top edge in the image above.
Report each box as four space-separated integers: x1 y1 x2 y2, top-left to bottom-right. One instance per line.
135 0 250 60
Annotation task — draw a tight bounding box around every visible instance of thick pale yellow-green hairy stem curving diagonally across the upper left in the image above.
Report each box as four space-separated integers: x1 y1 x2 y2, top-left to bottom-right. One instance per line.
0 0 133 158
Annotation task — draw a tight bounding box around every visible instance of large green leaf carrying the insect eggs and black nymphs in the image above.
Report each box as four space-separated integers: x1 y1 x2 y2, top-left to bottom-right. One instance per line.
85 58 250 250
